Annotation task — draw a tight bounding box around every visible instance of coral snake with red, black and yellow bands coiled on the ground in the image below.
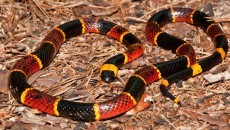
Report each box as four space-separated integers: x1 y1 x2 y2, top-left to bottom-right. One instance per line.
9 8 228 121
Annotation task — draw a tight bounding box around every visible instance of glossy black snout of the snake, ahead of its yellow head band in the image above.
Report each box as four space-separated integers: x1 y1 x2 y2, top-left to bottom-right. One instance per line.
101 70 116 83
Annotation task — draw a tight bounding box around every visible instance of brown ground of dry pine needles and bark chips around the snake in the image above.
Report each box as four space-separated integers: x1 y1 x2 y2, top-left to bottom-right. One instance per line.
0 0 230 130
